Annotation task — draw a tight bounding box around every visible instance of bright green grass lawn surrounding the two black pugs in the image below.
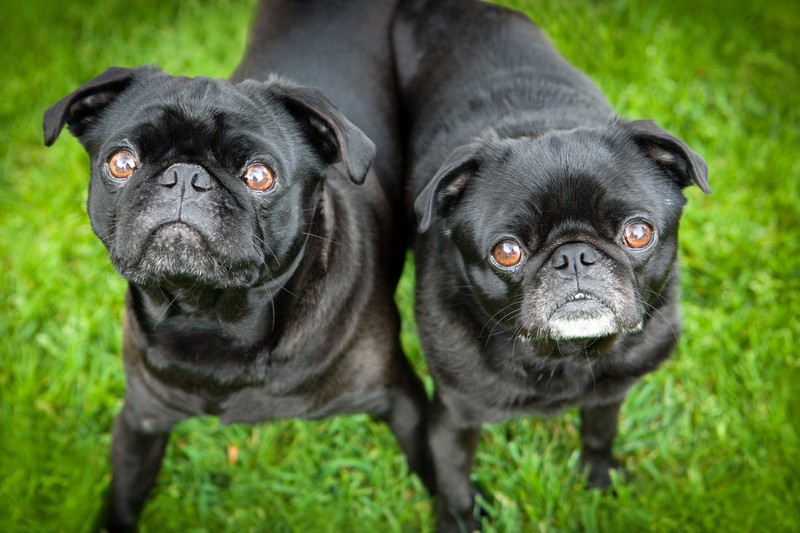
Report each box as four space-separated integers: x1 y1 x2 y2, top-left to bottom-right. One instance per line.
0 0 800 532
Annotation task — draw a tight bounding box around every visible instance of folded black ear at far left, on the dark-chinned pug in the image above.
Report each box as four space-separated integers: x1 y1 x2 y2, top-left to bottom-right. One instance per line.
43 67 134 146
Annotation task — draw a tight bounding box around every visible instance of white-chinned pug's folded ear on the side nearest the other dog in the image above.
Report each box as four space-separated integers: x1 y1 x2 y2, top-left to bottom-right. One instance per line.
414 143 480 233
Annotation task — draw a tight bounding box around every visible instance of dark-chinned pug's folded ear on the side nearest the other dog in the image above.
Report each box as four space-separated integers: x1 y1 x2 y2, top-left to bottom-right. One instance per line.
269 81 375 184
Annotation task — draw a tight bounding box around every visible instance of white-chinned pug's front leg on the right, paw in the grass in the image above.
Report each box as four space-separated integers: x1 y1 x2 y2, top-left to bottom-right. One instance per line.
580 400 623 489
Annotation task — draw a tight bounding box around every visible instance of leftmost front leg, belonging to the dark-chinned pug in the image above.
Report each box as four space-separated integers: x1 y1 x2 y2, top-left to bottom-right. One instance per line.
100 402 169 533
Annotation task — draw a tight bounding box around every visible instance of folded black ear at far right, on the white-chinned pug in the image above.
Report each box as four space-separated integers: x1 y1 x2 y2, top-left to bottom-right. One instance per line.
623 120 711 194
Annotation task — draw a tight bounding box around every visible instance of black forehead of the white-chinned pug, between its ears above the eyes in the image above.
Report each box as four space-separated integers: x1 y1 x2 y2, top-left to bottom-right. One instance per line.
467 130 682 232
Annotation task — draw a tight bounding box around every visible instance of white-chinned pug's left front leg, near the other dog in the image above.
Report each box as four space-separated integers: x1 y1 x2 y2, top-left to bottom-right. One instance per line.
429 393 481 533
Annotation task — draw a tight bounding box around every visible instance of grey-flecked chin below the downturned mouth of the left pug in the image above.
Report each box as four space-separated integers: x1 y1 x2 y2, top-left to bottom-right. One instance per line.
112 224 258 289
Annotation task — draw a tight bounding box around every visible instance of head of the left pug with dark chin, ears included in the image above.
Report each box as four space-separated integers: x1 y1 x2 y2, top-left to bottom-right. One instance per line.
44 68 375 288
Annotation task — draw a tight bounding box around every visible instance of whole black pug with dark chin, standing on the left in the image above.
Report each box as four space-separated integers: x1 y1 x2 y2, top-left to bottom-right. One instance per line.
44 0 431 531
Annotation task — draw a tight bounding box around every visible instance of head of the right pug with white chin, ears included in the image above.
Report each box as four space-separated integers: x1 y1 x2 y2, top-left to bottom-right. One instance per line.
415 121 710 342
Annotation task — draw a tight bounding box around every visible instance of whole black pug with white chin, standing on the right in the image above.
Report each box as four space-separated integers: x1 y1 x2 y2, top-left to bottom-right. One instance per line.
393 0 710 531
